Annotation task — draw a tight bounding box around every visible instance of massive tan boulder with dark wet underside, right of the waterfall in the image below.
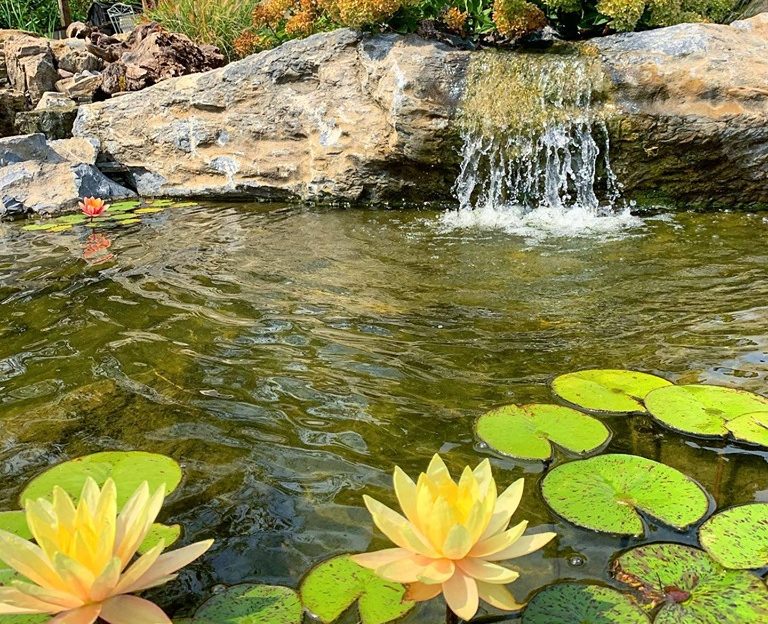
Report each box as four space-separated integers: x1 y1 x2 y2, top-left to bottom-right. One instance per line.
592 13 768 207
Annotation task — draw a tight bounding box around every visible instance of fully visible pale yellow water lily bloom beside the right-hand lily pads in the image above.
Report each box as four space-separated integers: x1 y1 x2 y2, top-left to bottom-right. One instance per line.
352 455 556 620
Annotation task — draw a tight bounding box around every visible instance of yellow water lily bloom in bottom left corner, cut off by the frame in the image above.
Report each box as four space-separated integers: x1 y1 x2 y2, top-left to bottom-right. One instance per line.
0 478 213 624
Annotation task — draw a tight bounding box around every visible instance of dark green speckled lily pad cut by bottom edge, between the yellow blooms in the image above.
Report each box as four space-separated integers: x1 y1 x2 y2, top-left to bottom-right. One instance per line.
186 585 303 624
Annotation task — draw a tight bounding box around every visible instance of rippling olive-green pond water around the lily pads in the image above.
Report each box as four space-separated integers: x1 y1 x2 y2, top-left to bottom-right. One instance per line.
0 206 768 624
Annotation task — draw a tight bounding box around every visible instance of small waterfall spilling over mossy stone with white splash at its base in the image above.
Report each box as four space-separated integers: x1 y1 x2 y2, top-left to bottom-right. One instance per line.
441 48 639 236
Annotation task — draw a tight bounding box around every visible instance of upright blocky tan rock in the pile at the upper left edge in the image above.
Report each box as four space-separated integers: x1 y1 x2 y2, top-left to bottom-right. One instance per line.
5 34 59 106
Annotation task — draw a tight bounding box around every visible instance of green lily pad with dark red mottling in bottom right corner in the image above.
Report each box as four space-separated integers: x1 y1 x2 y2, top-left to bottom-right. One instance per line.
612 544 768 624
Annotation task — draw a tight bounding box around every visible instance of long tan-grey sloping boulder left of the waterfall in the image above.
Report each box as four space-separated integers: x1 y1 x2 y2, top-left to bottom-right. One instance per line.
74 30 469 201
